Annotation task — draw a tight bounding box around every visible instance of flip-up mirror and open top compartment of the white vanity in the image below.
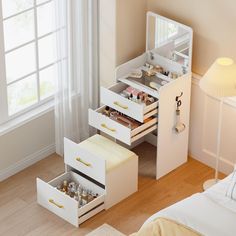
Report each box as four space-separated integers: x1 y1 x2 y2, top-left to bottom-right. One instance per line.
117 12 193 98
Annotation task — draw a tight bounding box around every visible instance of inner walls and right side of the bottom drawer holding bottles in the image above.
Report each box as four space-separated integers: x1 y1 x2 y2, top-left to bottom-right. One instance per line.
48 171 105 217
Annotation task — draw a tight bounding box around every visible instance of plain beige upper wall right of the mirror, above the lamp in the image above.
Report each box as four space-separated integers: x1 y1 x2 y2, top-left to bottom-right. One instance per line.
147 0 236 75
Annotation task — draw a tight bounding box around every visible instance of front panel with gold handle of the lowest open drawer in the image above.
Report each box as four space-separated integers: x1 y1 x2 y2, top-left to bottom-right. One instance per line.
37 178 78 227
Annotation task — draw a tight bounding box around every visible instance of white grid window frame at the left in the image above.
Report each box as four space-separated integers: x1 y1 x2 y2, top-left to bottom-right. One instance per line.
0 0 58 126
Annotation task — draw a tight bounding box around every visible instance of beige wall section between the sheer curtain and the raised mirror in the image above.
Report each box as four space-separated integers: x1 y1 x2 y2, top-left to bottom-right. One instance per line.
100 0 147 87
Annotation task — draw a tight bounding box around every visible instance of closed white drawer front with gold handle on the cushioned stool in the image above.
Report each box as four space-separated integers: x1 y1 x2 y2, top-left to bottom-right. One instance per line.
64 138 106 185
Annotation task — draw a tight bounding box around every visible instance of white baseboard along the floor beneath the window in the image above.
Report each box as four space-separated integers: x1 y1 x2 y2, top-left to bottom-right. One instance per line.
0 143 55 182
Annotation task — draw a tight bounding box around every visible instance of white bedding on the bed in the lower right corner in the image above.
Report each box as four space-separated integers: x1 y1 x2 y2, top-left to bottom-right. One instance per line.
144 176 236 236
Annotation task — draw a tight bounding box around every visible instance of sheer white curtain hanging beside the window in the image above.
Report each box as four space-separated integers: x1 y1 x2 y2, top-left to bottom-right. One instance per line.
55 0 99 155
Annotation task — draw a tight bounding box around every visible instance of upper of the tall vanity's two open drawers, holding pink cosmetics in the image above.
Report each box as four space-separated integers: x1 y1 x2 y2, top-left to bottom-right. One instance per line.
101 83 158 122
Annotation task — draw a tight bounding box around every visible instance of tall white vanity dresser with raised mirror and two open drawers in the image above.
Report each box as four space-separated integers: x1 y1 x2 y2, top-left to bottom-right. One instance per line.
89 12 193 179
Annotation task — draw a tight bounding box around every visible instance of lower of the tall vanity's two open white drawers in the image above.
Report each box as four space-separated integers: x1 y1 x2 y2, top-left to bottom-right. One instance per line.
89 106 157 145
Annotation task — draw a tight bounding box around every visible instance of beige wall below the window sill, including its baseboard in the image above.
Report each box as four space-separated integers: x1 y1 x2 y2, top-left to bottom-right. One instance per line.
0 111 55 181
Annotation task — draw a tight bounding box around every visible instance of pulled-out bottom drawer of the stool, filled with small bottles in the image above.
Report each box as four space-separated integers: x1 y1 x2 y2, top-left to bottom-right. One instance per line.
37 171 105 227
